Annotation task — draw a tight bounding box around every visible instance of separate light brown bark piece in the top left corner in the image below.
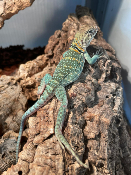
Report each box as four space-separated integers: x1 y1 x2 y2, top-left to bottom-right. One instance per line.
0 0 34 28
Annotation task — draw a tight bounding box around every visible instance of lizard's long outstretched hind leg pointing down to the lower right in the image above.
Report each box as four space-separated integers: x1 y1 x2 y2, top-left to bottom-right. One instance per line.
55 86 89 168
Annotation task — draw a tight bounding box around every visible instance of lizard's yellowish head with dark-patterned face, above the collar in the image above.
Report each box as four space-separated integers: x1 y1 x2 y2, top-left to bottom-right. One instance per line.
75 26 98 50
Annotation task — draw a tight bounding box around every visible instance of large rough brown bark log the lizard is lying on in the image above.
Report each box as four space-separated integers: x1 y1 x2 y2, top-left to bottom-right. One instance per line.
0 6 131 175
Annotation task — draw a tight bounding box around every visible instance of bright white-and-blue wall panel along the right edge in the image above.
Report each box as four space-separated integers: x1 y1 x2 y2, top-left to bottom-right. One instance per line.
102 0 131 124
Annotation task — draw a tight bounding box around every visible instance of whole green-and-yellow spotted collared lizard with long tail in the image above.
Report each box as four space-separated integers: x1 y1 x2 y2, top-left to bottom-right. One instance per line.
16 25 102 169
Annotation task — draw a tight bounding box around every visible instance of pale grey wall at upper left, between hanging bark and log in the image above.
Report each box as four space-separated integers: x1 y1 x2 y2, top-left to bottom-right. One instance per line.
0 0 85 48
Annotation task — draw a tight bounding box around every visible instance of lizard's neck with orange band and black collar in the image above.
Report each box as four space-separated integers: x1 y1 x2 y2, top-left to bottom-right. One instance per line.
69 38 85 54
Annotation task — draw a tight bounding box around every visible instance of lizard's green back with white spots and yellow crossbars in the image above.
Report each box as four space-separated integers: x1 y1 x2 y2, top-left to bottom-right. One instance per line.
46 49 84 90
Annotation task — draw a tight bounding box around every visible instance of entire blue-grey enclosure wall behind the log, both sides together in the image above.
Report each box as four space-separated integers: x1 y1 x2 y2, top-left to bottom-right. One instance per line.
0 0 131 123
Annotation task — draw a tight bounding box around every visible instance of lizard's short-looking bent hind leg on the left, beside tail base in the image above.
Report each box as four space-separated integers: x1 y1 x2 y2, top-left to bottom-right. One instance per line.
37 74 52 95
